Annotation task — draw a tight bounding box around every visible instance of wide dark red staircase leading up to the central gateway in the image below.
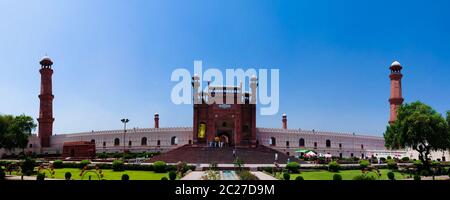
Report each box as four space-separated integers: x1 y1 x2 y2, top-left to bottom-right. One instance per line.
148 145 302 164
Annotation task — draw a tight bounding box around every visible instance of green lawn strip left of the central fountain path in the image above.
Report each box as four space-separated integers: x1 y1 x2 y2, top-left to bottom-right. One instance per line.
37 168 169 180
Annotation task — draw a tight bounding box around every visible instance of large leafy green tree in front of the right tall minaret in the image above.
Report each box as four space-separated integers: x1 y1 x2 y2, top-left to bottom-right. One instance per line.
384 101 450 170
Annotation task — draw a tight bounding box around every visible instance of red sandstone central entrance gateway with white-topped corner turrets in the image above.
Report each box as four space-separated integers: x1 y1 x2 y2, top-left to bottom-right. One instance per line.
192 76 257 147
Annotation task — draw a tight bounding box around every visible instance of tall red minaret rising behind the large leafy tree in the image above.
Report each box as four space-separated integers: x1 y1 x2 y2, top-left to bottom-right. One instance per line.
389 61 404 124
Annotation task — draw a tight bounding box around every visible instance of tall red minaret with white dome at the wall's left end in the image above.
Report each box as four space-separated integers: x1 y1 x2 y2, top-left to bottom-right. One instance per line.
38 56 55 147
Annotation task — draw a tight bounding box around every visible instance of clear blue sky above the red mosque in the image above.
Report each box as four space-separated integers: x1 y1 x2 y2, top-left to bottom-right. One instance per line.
0 0 450 136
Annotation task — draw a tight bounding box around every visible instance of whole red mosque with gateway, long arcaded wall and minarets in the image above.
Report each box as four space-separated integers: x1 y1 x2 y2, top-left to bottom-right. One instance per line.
5 56 448 162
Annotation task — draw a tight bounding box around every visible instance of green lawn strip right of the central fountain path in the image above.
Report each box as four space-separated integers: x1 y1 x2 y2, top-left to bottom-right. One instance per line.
291 169 408 180
